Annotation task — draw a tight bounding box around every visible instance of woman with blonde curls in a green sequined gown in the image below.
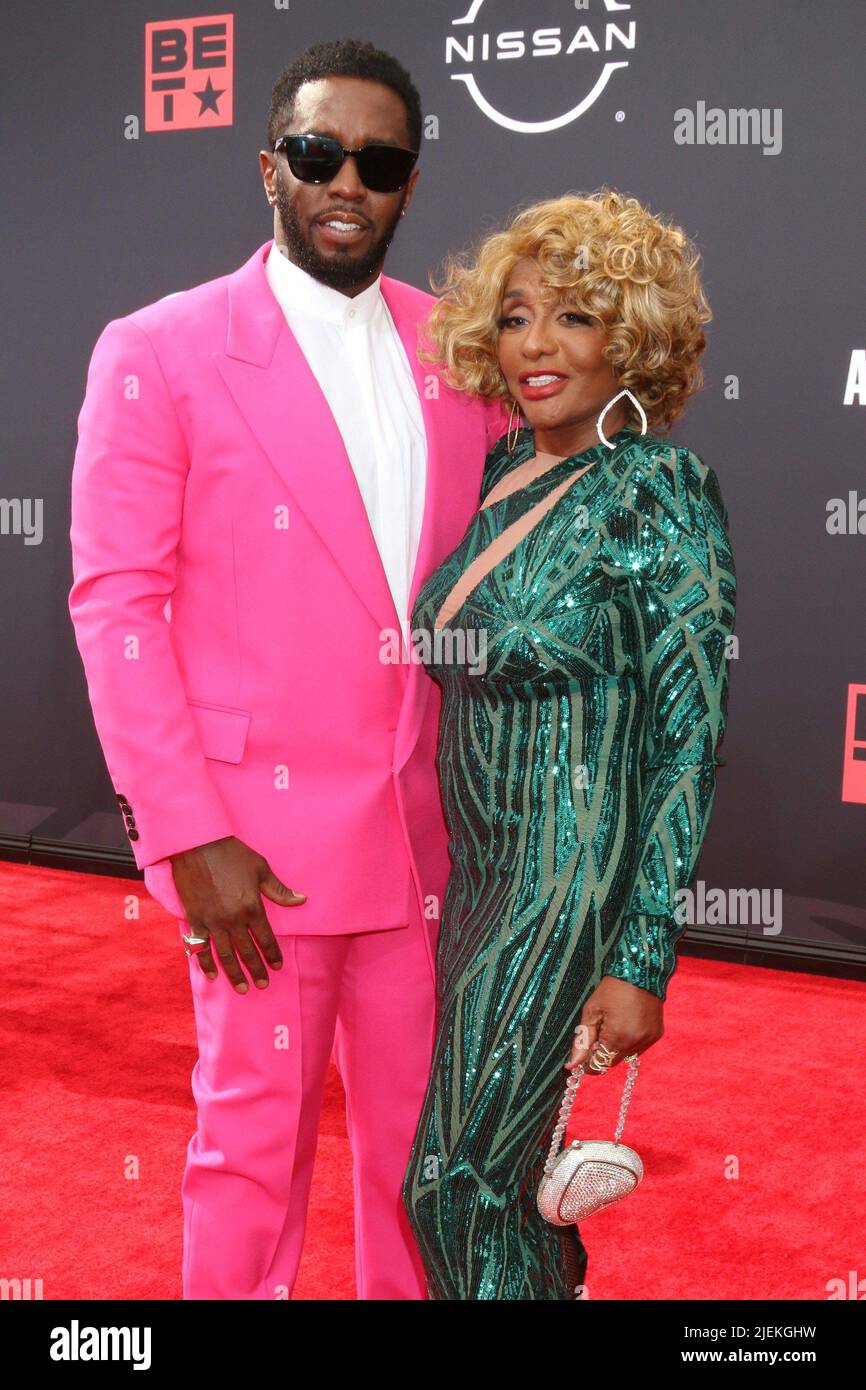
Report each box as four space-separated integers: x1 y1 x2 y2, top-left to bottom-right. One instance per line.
403 190 735 1300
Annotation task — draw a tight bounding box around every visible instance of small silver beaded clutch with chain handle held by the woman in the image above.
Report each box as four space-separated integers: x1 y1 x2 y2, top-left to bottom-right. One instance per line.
537 1056 644 1226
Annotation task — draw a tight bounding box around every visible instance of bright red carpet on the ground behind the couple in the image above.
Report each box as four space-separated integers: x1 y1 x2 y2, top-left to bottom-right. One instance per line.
0 863 866 1300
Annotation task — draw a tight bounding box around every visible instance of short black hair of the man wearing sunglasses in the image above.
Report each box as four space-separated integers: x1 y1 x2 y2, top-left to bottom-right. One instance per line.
268 39 423 150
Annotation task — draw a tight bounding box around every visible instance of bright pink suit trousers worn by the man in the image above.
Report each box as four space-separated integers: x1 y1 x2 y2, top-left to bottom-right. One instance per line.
179 901 435 1300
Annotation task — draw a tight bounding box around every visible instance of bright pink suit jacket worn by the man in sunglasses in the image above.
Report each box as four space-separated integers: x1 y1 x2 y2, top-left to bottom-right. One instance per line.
70 240 505 965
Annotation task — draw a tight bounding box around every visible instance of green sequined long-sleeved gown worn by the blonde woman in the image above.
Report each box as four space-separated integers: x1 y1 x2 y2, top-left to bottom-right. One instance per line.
403 430 735 1300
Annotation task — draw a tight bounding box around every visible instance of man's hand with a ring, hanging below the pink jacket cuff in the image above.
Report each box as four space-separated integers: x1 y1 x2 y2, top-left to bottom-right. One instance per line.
170 835 307 994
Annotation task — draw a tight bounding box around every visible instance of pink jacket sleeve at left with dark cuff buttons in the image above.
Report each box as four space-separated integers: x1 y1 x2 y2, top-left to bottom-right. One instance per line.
68 318 232 869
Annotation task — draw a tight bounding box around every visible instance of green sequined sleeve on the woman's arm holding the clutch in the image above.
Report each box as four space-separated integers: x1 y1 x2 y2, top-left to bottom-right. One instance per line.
603 450 737 999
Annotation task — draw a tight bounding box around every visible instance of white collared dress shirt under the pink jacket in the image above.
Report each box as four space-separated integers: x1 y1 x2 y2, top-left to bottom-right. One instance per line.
264 242 427 620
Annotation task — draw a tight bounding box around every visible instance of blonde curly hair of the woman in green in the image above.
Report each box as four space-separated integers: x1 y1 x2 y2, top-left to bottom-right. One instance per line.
420 188 713 432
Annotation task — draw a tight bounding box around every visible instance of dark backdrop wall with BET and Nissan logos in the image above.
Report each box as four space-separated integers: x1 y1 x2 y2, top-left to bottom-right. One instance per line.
0 0 866 972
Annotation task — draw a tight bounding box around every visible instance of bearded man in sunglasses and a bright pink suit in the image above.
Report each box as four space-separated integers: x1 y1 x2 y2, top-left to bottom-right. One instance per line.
70 40 505 1298
